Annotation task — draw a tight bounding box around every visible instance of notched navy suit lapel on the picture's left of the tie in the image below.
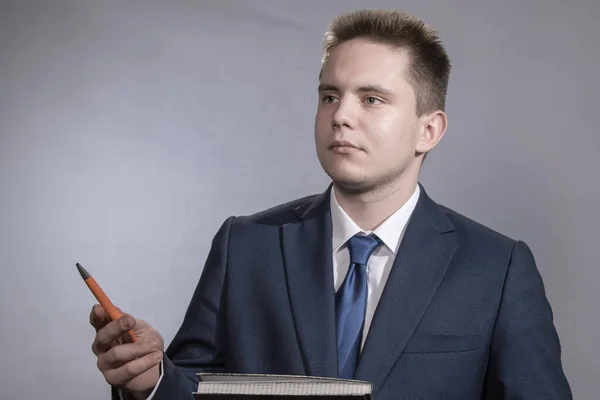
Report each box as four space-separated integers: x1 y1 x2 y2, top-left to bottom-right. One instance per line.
281 190 337 377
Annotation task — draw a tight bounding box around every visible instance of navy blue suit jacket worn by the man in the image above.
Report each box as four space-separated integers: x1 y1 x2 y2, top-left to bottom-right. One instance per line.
127 187 572 400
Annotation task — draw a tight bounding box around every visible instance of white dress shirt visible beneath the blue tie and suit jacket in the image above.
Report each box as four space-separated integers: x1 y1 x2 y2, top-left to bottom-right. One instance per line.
331 185 420 348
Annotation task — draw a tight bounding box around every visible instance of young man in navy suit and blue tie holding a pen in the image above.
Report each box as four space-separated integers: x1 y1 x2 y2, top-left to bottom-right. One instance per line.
91 11 571 400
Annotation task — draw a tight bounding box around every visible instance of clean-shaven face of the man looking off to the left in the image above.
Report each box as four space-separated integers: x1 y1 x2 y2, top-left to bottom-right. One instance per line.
315 39 423 191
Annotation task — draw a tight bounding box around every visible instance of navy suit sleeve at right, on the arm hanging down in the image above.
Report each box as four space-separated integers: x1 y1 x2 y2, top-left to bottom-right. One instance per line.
485 241 573 400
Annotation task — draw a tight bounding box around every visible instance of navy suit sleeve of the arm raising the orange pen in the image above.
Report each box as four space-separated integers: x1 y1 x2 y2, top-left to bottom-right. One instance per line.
119 217 234 400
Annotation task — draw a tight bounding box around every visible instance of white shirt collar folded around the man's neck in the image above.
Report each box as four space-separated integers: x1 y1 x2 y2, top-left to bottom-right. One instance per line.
330 185 421 254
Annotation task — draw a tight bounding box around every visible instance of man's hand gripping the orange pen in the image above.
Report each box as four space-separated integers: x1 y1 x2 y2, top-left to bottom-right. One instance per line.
90 304 164 399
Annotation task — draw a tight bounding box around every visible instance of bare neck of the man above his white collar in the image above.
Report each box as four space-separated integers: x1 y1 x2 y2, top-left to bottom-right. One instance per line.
334 179 418 231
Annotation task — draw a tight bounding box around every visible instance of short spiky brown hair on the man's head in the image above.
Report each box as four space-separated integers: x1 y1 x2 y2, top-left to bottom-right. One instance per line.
322 10 450 115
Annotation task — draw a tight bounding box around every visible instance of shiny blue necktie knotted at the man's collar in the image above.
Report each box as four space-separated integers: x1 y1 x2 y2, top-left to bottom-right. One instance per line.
335 235 381 379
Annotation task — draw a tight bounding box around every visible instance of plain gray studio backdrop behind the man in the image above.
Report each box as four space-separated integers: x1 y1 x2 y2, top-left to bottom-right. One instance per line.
0 0 600 400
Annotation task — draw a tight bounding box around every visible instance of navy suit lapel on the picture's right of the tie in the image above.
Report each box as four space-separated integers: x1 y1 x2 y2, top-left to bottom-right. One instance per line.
356 187 458 390
